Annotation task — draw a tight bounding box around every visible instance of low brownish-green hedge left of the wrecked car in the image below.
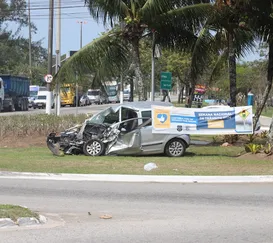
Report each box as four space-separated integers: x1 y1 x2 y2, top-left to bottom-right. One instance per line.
0 114 86 138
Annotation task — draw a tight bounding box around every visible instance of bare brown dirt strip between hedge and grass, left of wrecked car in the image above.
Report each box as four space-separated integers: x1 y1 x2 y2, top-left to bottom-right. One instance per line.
0 135 46 148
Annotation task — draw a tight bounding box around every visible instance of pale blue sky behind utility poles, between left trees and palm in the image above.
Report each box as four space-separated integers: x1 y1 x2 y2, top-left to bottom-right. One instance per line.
9 0 105 54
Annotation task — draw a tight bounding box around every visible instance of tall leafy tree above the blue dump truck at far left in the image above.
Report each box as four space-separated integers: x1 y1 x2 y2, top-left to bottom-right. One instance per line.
0 0 47 83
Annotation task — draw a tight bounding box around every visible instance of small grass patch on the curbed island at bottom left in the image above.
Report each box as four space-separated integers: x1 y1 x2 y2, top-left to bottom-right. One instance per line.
0 204 38 221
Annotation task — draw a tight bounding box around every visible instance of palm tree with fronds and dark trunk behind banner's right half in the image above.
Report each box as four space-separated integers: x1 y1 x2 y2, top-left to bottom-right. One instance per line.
191 0 255 106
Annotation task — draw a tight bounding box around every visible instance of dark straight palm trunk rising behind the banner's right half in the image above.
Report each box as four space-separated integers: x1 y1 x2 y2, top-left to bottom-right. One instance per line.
228 32 237 107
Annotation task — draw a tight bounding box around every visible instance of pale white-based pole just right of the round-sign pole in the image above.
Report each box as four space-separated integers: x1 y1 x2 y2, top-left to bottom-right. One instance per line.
55 0 61 116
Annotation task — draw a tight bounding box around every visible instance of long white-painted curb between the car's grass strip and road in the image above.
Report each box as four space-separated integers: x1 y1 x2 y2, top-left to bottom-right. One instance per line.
0 172 273 183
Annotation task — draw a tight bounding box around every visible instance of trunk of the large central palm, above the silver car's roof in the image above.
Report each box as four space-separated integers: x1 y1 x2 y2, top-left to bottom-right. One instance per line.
132 39 145 101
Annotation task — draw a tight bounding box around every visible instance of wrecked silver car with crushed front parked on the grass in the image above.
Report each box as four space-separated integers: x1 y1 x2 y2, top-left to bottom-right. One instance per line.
47 101 190 157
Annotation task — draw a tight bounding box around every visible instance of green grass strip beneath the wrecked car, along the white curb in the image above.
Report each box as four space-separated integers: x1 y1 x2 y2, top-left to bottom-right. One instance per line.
0 146 273 175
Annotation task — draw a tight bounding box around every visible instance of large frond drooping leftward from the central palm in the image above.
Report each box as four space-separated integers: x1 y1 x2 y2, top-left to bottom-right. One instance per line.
57 31 129 82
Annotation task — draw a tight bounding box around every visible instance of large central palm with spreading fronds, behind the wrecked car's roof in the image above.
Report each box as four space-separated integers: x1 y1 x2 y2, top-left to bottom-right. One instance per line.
56 0 211 100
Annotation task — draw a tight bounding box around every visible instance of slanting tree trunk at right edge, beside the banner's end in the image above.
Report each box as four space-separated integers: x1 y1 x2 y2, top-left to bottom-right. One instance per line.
254 40 273 139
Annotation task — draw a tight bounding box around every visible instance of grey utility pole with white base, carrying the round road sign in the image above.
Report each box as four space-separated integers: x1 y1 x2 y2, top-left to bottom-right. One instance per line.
46 0 54 115
